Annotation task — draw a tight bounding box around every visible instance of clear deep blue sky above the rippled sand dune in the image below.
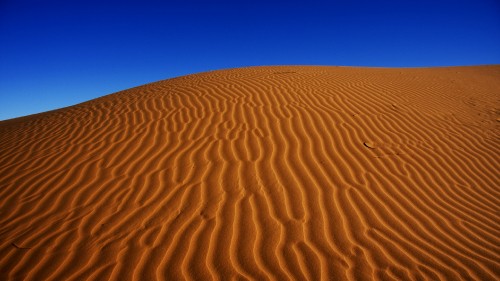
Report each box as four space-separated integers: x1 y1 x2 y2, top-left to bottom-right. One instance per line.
0 0 500 120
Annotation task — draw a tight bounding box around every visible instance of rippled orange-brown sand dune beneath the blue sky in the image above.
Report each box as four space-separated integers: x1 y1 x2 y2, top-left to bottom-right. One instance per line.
0 66 500 280
